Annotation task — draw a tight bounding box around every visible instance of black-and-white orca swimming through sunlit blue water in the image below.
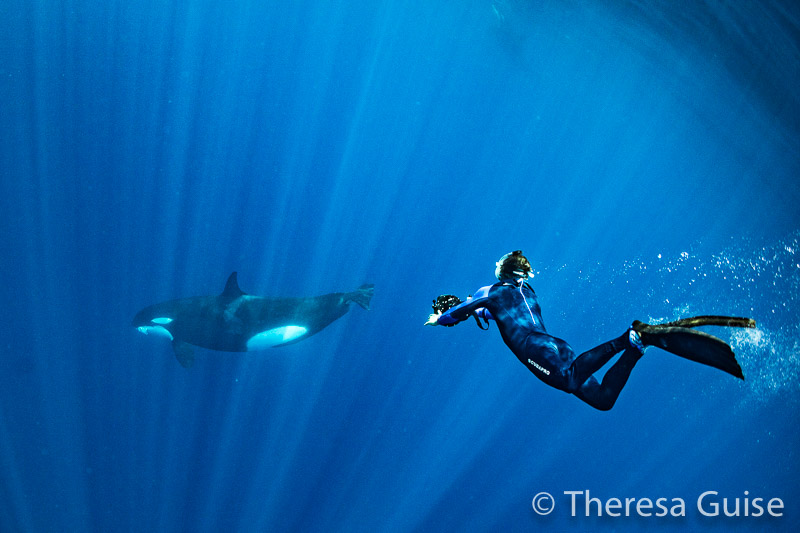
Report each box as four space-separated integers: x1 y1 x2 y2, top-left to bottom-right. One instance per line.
132 272 374 368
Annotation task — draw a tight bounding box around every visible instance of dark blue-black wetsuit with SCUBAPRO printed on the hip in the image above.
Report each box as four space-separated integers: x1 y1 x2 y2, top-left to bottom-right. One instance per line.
438 279 641 410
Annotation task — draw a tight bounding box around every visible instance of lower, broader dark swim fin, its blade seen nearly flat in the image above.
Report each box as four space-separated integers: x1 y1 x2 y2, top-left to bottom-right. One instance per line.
632 317 754 379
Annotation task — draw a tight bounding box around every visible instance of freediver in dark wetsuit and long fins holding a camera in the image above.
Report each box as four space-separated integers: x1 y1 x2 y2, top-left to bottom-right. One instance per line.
425 250 755 411
